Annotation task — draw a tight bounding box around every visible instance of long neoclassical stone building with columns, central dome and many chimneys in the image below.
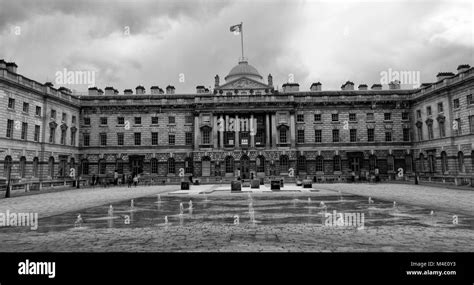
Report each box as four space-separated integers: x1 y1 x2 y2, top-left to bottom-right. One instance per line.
0 57 474 190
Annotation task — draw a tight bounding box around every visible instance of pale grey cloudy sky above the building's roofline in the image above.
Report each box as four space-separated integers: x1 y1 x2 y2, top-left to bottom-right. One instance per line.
0 0 474 93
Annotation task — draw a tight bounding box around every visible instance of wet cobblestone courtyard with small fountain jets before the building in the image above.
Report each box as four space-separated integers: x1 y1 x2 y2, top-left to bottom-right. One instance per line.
0 184 474 252
